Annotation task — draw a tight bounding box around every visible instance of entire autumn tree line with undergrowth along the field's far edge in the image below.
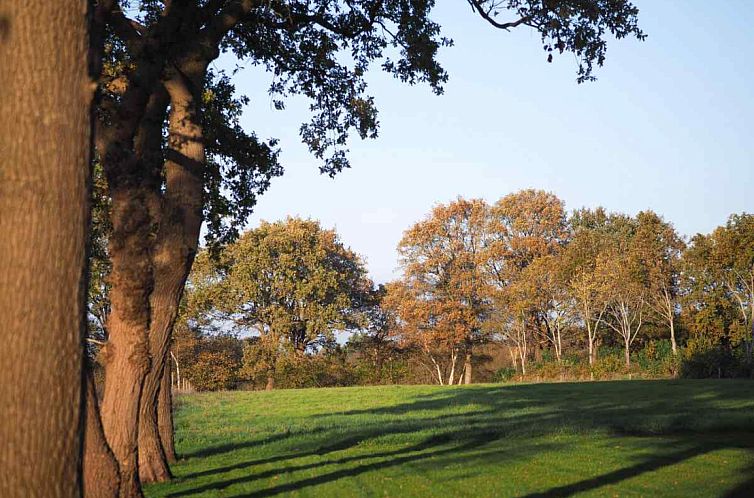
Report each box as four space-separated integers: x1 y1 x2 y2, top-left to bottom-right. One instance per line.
169 190 754 389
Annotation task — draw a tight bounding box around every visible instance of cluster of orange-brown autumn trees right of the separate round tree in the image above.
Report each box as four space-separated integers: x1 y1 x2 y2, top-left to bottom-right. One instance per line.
386 190 754 384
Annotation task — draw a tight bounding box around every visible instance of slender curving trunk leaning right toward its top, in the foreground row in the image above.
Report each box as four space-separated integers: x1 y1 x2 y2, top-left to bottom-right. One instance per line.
139 66 205 482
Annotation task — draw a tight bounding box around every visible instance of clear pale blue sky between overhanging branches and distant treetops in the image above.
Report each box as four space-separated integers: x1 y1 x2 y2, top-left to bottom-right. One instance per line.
220 0 754 282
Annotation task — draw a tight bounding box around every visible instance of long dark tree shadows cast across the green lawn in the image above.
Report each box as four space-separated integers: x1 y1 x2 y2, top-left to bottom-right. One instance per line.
168 381 754 498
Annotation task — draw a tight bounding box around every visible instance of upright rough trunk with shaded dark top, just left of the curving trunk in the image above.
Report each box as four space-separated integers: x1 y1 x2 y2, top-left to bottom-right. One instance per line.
100 87 167 497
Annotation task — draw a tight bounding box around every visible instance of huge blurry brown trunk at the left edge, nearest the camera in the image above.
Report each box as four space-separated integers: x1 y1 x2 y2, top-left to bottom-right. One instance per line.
0 0 93 498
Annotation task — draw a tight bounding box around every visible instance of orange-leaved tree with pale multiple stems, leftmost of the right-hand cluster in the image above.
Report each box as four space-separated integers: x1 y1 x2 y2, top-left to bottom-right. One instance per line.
391 198 490 384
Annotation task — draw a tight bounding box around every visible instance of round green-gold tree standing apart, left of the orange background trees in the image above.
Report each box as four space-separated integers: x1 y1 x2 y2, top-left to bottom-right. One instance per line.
185 218 372 388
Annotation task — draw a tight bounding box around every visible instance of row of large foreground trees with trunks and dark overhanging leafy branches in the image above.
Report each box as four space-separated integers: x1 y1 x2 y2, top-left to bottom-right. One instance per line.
0 0 644 497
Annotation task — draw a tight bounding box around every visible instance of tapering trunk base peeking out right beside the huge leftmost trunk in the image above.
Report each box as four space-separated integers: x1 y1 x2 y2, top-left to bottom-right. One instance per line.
83 368 120 498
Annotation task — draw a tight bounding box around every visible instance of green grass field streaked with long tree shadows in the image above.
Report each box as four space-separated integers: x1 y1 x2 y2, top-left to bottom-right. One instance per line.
146 380 754 498
